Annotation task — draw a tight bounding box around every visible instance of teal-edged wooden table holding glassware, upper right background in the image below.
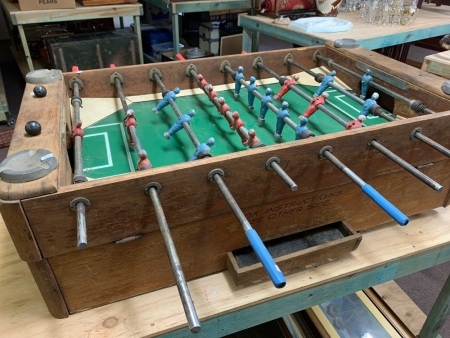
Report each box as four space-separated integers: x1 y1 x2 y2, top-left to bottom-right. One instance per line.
238 4 450 52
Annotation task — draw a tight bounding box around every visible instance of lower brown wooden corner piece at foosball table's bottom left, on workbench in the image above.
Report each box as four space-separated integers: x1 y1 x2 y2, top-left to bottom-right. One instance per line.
28 259 69 318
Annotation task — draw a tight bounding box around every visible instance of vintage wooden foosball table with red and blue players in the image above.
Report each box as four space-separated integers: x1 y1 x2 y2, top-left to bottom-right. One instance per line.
0 44 450 332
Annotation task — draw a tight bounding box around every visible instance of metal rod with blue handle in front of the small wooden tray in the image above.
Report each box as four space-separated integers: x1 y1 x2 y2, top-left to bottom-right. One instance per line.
208 169 286 288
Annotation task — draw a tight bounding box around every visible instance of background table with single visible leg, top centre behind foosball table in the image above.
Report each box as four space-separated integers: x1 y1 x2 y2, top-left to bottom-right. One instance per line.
143 0 251 54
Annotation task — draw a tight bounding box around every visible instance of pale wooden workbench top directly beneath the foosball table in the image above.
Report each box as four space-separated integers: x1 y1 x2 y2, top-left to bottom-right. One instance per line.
0 208 450 338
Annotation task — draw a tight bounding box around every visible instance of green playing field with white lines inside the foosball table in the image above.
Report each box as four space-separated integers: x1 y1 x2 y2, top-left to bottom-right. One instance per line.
82 84 385 179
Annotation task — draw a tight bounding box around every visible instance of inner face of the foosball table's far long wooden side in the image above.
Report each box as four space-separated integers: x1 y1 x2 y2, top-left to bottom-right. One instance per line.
64 47 324 97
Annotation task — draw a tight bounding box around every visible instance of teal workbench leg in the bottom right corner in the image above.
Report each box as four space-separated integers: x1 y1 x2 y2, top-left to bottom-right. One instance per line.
418 276 450 338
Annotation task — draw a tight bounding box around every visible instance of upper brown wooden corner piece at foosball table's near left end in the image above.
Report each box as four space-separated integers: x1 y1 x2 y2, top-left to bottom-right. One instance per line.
0 201 42 261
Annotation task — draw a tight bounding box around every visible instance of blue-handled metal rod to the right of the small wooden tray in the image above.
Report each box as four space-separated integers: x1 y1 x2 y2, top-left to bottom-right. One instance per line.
319 146 409 225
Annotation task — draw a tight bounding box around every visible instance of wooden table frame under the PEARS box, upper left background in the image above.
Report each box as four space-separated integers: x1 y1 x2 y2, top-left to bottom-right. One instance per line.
1 0 144 71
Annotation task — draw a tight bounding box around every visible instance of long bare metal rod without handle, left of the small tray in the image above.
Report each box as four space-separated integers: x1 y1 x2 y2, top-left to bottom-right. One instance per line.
146 183 201 333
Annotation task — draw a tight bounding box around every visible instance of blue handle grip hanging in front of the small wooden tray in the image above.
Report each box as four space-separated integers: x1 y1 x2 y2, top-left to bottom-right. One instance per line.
245 229 286 289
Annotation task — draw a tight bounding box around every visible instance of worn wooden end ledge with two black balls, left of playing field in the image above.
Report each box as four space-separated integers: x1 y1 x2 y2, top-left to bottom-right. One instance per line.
0 77 70 200
